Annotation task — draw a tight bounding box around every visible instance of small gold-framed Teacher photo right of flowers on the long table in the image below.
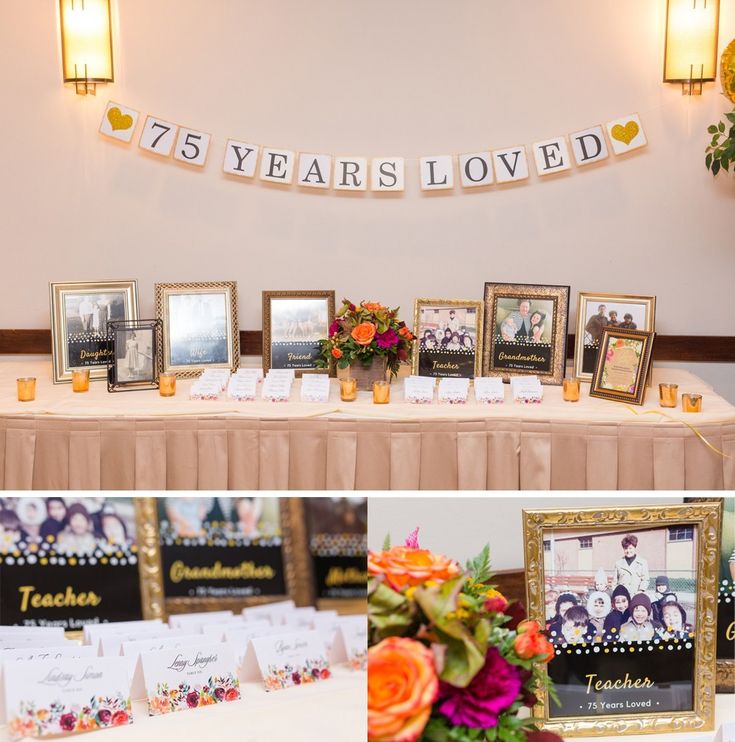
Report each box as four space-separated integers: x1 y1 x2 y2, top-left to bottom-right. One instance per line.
412 299 483 379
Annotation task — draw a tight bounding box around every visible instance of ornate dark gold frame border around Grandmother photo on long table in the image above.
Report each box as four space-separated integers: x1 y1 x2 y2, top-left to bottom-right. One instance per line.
482 282 570 384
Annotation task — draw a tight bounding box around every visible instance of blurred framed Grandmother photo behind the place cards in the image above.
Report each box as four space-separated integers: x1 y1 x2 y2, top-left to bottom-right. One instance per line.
154 497 313 613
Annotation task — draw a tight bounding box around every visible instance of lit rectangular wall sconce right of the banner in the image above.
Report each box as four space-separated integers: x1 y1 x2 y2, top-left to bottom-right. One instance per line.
664 0 720 95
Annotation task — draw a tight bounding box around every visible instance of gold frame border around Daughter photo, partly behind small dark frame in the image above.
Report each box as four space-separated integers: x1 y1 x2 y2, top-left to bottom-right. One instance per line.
49 280 138 384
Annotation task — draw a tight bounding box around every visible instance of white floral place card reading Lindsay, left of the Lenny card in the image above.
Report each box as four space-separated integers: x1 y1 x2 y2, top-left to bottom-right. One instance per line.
5 657 133 740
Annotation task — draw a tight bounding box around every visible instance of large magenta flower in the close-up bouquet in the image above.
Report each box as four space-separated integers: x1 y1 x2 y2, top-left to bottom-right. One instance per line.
439 647 522 729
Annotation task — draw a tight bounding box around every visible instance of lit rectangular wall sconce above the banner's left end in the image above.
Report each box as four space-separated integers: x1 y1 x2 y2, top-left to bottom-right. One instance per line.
60 0 114 95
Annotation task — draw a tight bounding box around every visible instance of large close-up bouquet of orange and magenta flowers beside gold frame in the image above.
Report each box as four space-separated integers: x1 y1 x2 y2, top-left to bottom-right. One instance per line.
368 529 561 742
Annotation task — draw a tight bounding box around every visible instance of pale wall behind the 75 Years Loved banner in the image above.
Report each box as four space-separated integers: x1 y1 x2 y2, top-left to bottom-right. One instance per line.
0 0 735 397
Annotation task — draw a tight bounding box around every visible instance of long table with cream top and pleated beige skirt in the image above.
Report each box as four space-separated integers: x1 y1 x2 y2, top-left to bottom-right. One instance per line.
0 361 735 490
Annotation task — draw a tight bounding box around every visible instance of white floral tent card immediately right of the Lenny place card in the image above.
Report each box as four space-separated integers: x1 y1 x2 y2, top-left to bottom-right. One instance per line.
242 630 331 691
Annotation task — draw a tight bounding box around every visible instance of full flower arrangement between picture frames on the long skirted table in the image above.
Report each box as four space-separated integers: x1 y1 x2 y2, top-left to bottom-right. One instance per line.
317 299 415 376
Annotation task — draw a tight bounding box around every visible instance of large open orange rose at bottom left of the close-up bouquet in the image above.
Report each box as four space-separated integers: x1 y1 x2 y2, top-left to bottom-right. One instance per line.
368 636 439 742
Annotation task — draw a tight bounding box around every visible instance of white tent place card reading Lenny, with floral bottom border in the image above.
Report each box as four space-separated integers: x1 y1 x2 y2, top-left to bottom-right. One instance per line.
140 642 240 716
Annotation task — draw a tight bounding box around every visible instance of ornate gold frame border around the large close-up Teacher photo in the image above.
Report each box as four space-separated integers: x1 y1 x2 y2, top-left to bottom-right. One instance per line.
523 502 722 739
